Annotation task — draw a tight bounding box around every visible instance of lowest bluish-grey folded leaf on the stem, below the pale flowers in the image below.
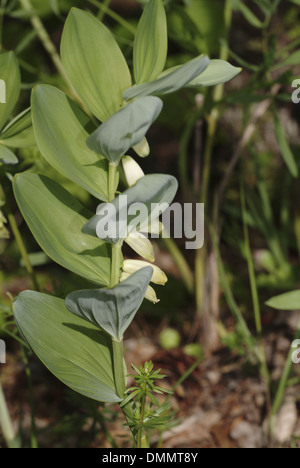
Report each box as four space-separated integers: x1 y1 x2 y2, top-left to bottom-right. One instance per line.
66 266 153 341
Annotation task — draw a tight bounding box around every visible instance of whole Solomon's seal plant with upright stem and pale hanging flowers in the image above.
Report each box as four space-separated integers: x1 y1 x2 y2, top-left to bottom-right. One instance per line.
13 0 239 446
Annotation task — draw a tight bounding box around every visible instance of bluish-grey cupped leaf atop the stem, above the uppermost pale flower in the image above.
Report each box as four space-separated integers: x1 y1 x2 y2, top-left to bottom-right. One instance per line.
87 96 163 164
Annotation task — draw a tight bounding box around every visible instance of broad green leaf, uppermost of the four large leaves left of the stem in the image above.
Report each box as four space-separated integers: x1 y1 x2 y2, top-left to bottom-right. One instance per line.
61 8 131 122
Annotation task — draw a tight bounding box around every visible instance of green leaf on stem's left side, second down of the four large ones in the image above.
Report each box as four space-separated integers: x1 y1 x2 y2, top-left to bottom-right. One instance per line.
32 85 108 201
